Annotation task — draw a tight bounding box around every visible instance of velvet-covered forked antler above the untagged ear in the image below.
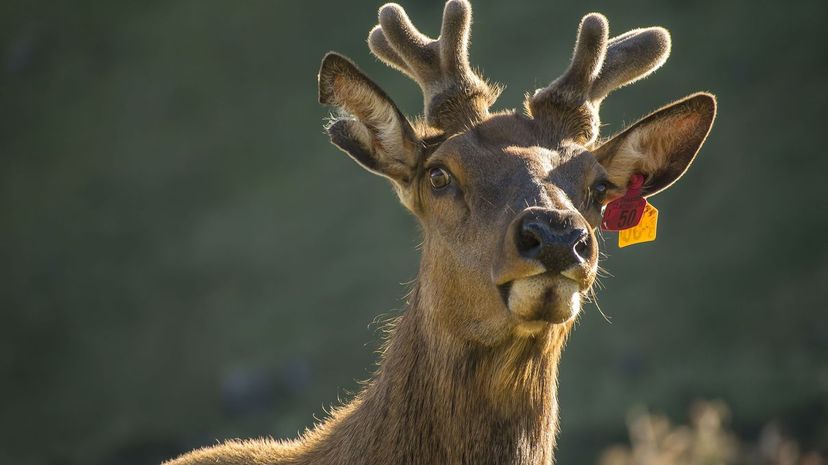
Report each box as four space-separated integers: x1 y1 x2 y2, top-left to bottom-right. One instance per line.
368 0 500 133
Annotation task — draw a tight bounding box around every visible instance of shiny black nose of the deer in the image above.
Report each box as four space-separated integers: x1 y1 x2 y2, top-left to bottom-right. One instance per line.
515 210 592 272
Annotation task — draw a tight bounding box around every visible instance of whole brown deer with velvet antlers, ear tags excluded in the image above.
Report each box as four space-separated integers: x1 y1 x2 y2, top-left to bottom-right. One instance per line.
167 0 716 465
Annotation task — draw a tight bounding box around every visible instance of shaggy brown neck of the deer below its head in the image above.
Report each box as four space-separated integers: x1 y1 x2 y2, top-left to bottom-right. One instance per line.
308 285 569 465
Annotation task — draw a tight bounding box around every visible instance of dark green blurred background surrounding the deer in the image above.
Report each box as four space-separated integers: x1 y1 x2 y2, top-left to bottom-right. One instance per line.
0 0 828 465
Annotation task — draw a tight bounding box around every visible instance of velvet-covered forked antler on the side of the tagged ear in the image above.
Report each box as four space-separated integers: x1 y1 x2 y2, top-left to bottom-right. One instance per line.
527 13 670 145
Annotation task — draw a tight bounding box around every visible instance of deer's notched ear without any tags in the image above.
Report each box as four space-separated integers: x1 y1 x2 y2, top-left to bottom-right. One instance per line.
319 52 421 187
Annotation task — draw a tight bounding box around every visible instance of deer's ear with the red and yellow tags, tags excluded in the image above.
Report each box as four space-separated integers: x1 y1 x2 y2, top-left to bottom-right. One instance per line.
593 93 716 197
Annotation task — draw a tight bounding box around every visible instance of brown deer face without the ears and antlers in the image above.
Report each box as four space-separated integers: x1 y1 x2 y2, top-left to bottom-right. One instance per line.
415 114 610 334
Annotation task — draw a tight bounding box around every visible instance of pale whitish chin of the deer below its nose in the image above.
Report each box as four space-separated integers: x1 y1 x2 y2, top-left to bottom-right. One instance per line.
509 274 581 332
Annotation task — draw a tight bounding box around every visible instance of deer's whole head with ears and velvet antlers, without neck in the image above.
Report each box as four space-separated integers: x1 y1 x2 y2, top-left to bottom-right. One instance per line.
319 0 716 346
